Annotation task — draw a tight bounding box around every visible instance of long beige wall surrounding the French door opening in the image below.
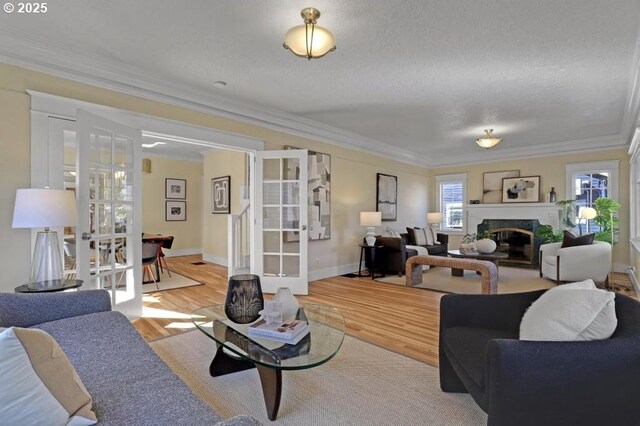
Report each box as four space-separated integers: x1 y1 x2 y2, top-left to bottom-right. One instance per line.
0 64 428 291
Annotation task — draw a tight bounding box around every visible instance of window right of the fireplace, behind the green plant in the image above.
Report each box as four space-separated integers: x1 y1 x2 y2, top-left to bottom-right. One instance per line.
566 160 619 233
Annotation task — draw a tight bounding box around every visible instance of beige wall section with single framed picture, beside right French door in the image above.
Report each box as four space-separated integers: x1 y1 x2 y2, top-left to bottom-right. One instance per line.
202 150 246 265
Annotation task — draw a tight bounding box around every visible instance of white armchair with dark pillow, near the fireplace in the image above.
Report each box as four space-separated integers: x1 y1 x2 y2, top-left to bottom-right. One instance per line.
540 241 611 287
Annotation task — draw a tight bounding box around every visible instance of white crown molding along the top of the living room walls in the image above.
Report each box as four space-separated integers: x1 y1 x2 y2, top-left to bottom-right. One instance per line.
0 30 640 168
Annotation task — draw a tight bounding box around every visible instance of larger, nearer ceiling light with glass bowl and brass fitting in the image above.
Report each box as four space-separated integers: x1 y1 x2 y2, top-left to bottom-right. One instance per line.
282 7 336 60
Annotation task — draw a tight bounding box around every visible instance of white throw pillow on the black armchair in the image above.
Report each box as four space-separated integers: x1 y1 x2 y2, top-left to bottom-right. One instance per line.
520 280 618 341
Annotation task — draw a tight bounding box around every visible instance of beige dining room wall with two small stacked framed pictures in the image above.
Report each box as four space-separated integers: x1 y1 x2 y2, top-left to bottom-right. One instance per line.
142 155 203 256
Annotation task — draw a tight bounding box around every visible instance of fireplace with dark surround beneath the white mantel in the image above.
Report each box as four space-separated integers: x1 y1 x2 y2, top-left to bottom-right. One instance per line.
477 219 541 268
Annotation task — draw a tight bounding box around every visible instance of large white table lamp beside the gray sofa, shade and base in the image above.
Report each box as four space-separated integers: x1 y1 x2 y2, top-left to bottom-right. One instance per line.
12 188 78 283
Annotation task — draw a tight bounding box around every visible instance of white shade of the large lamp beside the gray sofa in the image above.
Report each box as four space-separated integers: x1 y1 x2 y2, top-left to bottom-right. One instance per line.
12 188 78 228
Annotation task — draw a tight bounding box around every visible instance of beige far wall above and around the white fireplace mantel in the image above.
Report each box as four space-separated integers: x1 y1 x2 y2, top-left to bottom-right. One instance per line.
429 149 629 265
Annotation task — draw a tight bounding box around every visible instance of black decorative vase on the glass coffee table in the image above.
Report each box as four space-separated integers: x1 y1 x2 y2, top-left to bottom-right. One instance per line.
224 274 264 324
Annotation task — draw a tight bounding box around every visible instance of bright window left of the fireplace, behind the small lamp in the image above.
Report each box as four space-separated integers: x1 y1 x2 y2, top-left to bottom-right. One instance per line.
436 174 467 233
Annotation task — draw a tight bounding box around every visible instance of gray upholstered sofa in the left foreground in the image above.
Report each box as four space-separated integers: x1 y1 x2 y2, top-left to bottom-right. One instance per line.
0 290 260 426
